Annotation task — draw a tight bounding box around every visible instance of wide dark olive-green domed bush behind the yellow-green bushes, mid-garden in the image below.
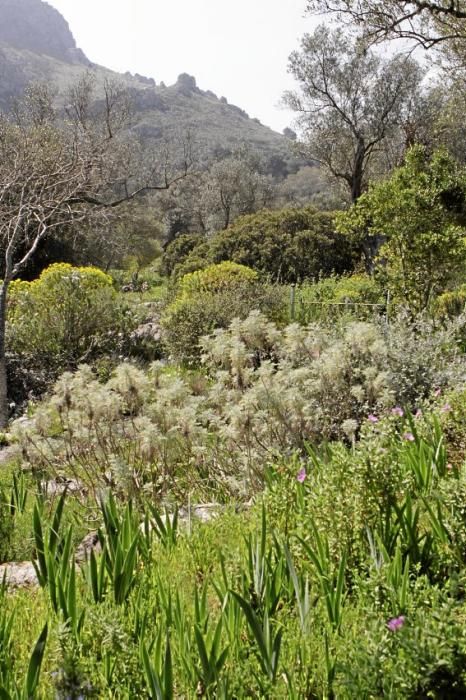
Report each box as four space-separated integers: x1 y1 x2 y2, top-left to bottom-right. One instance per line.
164 207 358 282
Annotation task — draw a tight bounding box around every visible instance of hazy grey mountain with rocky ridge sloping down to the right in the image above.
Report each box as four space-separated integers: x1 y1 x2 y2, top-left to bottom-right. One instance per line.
0 0 303 176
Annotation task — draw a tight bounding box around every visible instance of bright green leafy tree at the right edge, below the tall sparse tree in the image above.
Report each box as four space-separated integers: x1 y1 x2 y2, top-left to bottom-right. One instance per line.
337 147 466 312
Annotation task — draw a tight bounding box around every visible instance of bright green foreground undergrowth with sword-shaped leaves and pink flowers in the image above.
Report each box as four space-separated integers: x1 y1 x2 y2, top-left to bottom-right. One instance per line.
0 391 466 698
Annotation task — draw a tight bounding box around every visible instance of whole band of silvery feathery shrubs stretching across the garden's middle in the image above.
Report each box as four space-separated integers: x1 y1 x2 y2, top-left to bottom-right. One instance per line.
11 312 466 498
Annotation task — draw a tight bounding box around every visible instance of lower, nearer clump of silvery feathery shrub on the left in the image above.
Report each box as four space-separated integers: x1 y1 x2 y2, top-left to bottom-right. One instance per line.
13 363 210 496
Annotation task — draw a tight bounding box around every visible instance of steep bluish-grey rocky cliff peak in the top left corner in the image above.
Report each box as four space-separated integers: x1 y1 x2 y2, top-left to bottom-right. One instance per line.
0 0 89 65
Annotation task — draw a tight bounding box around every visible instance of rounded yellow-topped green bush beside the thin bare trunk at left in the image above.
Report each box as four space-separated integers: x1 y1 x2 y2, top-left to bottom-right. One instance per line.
7 263 128 368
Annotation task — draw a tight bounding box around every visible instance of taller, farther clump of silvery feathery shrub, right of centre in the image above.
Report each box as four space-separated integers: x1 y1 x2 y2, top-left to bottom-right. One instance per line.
204 312 392 459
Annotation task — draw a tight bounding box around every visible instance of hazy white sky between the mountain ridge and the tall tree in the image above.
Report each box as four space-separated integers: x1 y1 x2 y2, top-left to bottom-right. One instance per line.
48 0 316 131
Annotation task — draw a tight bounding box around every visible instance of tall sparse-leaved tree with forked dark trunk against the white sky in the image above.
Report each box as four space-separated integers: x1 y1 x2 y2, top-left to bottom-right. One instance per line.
284 25 422 202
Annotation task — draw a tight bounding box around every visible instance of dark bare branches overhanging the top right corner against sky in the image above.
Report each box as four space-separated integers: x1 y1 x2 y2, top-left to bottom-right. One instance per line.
307 0 466 49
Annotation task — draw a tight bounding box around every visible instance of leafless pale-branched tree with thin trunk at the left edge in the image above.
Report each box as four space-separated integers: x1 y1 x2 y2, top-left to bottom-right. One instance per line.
0 76 190 427
